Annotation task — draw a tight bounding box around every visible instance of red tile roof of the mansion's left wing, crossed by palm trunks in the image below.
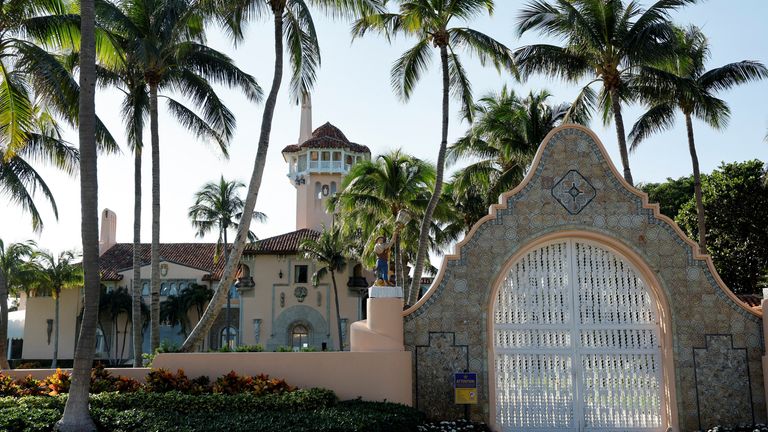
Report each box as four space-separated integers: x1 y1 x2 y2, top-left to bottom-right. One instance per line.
99 243 226 281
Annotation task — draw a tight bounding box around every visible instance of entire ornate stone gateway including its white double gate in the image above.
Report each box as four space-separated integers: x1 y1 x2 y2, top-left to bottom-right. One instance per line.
403 125 766 431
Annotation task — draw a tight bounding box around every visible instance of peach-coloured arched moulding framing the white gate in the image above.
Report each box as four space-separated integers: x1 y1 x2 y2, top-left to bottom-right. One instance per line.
486 230 678 430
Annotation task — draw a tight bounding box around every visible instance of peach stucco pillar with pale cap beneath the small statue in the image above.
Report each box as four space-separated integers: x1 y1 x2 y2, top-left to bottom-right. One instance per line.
349 286 404 352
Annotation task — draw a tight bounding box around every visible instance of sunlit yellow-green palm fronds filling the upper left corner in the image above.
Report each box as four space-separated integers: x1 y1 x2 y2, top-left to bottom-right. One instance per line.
0 0 117 231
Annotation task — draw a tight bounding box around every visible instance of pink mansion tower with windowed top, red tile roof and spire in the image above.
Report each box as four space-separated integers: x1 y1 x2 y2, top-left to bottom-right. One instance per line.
283 94 371 231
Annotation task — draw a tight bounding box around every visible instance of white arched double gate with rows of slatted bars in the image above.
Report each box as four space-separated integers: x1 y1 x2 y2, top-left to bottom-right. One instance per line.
493 240 662 431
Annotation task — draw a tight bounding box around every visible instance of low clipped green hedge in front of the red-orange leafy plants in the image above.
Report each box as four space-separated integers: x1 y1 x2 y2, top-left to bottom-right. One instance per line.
0 389 424 432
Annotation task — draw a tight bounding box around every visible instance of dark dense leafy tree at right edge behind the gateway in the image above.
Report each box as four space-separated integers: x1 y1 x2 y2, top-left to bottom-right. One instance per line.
676 160 768 294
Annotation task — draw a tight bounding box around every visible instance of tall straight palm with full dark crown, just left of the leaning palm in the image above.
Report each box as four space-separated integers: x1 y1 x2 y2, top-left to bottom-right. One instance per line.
99 0 261 350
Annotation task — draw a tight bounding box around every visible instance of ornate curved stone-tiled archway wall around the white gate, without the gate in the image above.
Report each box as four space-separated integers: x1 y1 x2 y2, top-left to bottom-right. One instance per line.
404 126 766 431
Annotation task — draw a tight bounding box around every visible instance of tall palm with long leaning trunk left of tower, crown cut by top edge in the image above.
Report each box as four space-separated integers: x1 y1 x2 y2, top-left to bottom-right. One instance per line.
181 0 380 351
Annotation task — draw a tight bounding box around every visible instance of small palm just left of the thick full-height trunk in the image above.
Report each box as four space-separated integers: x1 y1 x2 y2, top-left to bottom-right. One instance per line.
32 250 83 369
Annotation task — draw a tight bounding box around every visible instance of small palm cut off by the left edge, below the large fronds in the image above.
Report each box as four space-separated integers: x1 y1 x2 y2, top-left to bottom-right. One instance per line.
0 239 35 369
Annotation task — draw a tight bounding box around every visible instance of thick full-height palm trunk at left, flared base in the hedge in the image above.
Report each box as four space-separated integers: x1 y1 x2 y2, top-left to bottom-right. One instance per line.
56 0 101 426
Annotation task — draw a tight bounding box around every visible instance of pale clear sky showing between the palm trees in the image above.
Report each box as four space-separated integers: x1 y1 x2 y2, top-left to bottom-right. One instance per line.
0 0 768 251
